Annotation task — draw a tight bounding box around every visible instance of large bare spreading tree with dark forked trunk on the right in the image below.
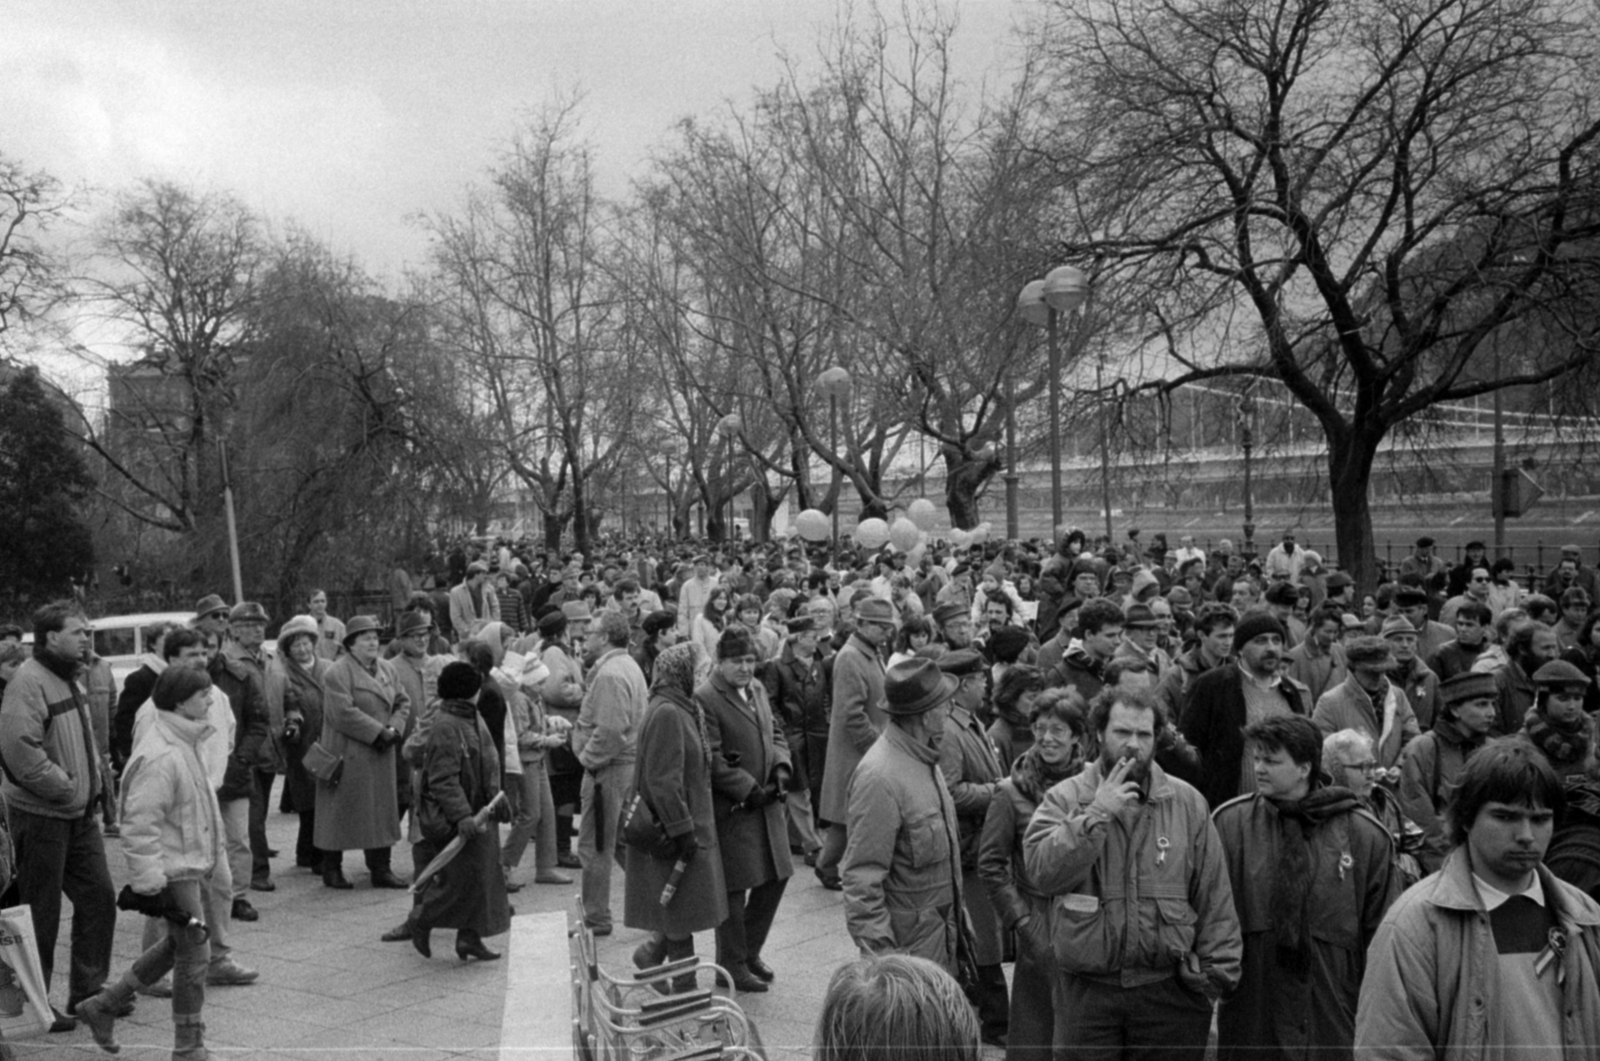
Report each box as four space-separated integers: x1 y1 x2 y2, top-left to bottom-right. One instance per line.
1030 0 1600 584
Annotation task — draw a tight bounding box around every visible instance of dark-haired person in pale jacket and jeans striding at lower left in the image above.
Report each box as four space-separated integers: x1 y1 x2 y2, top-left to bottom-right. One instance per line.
77 667 226 1061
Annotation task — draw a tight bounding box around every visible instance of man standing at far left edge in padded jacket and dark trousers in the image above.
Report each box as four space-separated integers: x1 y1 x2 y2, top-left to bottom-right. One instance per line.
0 600 119 1032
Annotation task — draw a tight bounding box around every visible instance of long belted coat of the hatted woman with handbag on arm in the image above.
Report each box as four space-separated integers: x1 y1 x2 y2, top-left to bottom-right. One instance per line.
315 655 411 851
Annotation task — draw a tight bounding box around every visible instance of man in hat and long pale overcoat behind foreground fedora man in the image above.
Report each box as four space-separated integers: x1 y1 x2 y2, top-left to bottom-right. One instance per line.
816 597 894 890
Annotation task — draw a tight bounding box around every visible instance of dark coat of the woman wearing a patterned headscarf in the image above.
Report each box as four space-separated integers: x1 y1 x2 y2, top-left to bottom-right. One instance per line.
622 690 728 936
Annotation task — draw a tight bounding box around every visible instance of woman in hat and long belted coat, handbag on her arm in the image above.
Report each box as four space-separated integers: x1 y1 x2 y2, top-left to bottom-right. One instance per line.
315 615 411 888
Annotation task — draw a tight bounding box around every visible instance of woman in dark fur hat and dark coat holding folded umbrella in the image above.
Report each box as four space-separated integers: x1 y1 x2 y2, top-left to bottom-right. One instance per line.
411 663 510 962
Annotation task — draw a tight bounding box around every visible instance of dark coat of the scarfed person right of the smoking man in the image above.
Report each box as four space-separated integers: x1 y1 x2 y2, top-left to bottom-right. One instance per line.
1213 794 1398 1061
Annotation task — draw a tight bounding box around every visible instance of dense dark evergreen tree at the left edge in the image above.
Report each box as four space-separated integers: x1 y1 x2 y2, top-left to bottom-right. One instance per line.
0 370 94 611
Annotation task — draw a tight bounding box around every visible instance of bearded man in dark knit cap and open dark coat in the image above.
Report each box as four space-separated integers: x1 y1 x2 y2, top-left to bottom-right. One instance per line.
1179 611 1310 807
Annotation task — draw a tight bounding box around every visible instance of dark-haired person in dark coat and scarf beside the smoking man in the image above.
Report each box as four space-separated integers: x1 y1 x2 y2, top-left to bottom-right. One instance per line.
1213 715 1398 1061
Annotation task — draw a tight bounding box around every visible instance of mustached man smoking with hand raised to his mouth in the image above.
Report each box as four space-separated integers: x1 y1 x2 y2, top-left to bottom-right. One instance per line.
1022 688 1243 1061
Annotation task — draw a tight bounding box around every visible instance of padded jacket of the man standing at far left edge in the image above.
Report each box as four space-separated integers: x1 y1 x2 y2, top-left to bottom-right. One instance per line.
0 656 104 819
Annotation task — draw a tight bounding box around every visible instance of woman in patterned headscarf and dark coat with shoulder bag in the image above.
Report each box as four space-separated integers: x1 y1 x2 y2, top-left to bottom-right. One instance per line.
622 642 728 991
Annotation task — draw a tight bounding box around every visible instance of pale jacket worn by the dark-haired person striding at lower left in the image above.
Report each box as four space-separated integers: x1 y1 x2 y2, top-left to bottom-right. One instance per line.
118 711 227 895
